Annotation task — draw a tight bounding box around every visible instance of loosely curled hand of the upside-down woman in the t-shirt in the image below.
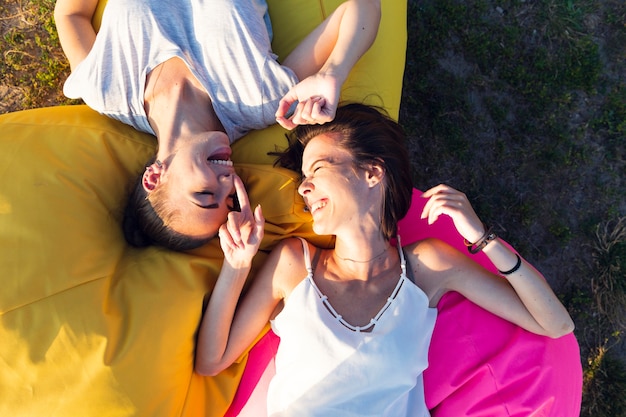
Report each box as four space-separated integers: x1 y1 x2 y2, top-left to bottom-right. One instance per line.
276 73 341 130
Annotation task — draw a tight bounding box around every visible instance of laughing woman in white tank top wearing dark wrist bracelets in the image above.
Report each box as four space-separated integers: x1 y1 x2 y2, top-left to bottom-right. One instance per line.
196 104 574 416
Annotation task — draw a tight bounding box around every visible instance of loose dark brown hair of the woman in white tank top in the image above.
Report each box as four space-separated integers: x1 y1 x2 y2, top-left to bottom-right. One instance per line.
273 103 413 239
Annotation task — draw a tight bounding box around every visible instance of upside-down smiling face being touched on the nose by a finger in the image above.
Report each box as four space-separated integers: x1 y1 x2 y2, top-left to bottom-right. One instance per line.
161 132 235 238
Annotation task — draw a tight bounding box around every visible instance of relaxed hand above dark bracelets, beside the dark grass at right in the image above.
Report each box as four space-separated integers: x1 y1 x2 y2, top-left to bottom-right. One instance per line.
421 184 486 242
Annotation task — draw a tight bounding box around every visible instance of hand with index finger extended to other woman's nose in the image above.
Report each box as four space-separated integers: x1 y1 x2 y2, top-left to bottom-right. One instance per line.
219 175 265 268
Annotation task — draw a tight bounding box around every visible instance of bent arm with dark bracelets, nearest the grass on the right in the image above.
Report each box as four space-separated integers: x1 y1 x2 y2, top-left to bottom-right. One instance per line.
419 185 574 338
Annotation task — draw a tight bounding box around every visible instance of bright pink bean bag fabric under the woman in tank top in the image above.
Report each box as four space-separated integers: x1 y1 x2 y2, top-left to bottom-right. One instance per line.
226 190 582 417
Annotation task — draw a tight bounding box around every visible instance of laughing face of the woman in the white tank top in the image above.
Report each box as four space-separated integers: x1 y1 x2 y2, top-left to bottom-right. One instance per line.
298 134 372 235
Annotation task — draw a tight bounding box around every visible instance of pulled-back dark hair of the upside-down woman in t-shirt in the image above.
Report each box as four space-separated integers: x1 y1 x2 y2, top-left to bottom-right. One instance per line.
122 165 211 251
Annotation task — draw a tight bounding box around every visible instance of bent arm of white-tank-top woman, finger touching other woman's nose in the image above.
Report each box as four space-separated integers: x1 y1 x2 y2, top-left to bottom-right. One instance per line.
195 177 306 375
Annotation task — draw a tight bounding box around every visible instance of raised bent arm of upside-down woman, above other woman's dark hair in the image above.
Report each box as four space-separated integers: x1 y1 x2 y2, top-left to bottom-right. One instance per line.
276 0 381 129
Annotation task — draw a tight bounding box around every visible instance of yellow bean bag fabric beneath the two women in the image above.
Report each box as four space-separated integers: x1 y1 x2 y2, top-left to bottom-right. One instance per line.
0 0 406 417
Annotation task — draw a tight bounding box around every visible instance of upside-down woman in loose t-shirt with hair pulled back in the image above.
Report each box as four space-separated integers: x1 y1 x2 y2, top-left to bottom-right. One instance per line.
55 0 380 250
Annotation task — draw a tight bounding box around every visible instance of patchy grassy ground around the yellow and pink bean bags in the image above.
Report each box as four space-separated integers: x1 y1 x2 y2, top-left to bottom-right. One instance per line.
0 0 626 417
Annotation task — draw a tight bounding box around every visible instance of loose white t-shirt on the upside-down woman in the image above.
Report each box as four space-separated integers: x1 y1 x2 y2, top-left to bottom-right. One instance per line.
63 0 298 142
